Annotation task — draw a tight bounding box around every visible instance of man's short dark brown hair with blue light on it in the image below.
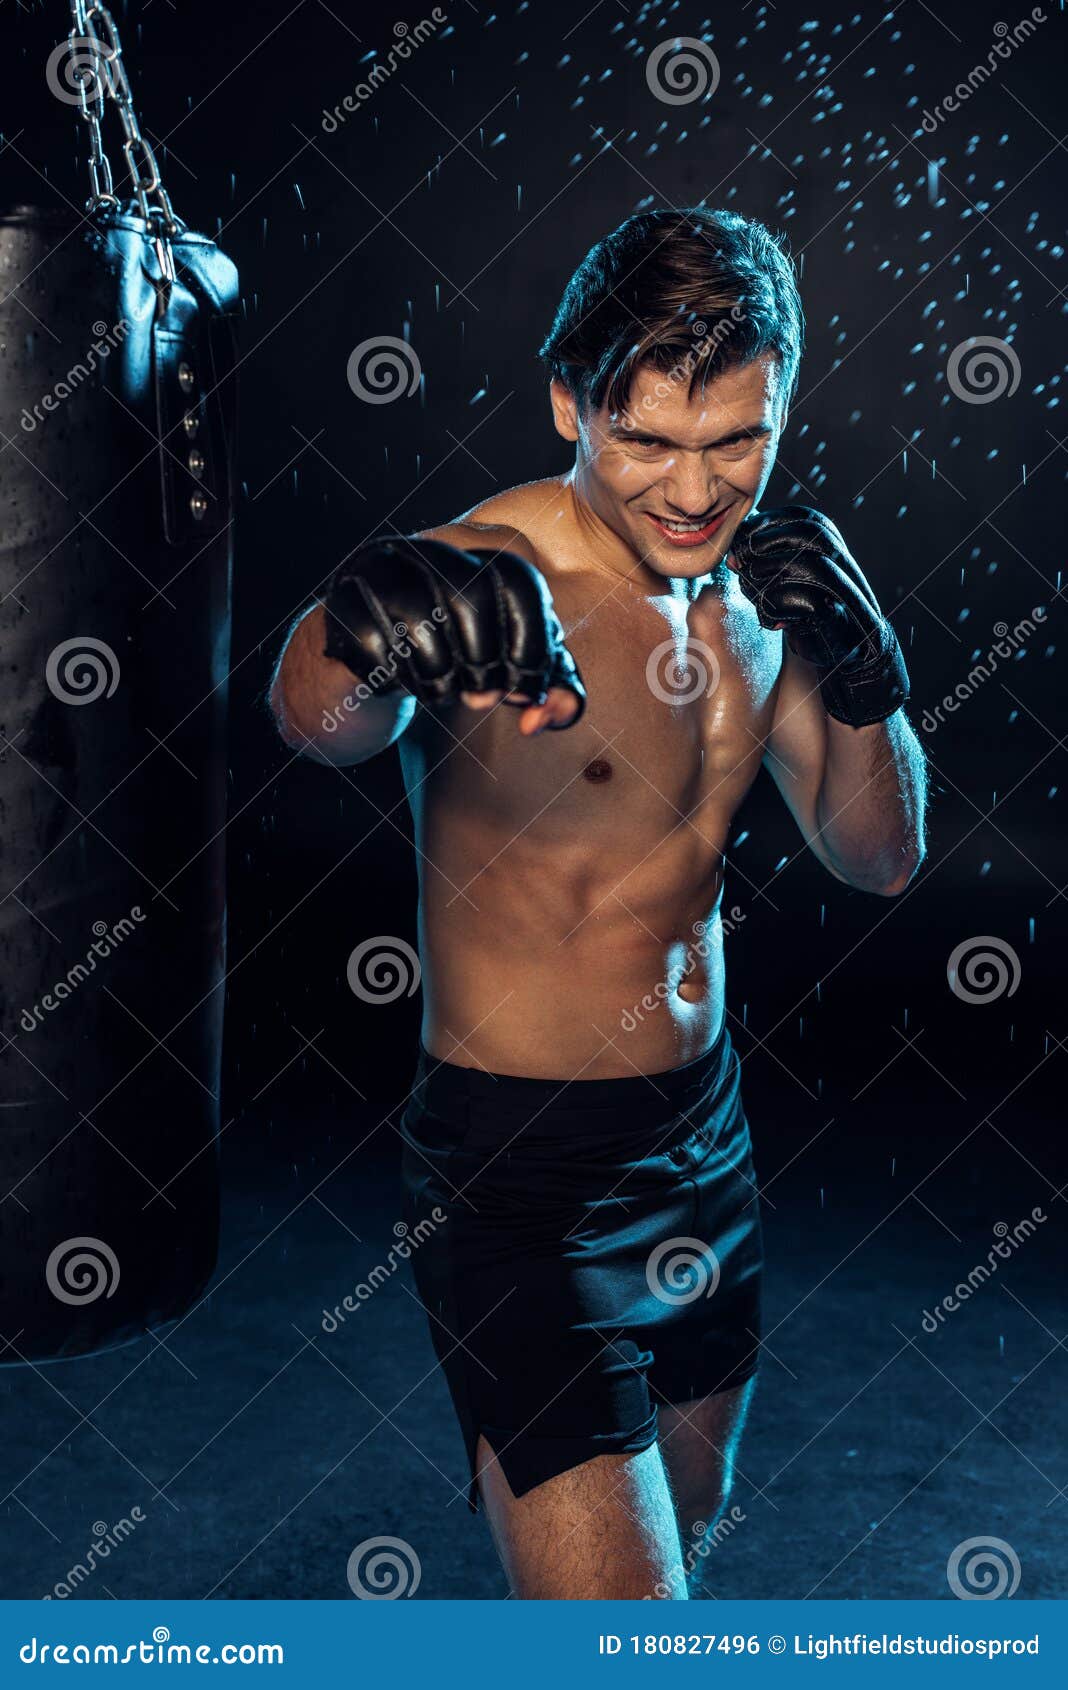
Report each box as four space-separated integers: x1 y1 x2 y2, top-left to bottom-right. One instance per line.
539 206 804 414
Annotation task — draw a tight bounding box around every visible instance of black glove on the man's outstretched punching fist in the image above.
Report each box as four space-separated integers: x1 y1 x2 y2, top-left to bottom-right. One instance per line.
319 539 586 728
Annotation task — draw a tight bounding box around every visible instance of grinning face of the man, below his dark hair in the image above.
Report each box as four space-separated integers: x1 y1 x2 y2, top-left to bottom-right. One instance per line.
553 353 786 576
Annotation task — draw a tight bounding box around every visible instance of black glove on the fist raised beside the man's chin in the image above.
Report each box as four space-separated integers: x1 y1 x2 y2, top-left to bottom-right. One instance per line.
732 505 909 728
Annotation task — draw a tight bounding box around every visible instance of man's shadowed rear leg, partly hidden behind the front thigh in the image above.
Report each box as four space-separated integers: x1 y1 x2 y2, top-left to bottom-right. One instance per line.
657 1379 755 1597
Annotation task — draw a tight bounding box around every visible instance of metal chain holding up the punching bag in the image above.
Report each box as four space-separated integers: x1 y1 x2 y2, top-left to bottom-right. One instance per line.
68 0 181 241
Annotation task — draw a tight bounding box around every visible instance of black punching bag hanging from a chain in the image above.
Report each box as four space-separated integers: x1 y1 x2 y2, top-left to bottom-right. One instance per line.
0 201 237 1364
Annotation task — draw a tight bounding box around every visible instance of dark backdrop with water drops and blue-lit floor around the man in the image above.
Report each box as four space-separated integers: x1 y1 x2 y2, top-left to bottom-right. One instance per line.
0 0 1068 1597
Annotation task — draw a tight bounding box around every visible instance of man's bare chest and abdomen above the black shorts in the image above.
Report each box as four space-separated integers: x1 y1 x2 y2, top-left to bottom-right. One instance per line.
399 530 767 1080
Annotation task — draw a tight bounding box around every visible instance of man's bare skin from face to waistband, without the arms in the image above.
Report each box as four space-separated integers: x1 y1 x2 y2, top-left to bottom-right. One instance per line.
397 357 797 1078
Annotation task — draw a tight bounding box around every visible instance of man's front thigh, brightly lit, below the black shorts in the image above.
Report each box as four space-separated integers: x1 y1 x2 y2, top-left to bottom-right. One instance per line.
478 1438 686 1600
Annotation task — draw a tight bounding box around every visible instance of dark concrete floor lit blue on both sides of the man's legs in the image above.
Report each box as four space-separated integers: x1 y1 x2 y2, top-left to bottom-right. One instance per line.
0 1095 1068 1600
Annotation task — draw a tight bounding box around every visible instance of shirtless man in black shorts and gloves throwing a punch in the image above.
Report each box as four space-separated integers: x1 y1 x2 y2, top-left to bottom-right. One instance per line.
272 210 924 1599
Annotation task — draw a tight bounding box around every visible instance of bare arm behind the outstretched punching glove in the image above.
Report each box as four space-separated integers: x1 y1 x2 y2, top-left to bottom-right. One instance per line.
269 603 416 764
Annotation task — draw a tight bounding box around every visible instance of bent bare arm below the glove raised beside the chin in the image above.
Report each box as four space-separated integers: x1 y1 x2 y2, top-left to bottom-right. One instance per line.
766 649 926 897
